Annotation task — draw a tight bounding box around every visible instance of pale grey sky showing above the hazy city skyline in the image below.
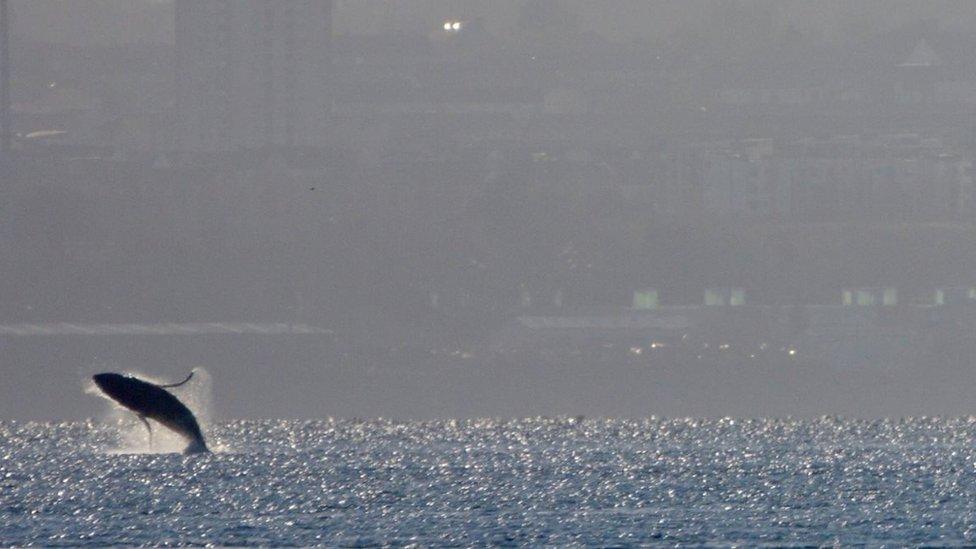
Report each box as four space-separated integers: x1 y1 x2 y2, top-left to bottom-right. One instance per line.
10 0 976 45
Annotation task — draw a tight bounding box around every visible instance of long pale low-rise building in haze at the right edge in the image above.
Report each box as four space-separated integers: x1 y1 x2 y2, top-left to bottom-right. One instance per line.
702 134 976 222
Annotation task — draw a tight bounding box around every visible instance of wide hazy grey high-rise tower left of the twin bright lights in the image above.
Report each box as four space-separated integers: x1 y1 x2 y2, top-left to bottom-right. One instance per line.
174 0 332 152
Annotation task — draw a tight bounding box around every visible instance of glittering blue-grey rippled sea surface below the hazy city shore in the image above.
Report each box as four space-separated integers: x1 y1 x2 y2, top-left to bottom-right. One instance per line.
0 418 976 546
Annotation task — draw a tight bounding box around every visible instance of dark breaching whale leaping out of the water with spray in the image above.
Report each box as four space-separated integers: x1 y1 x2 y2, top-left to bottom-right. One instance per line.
92 373 210 454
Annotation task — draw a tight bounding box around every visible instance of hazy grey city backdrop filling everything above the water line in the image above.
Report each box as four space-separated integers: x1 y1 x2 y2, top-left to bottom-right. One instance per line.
0 0 976 420
